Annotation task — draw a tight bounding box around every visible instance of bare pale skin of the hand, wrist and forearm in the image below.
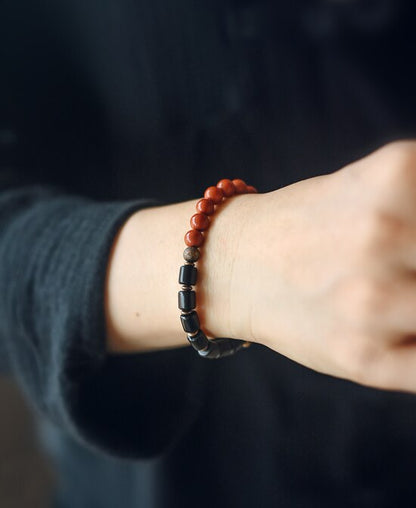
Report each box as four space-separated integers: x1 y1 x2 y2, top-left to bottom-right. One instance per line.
106 141 416 392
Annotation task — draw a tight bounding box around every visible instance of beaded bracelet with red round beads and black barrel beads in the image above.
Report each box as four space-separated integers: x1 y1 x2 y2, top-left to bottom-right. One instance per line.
178 179 257 359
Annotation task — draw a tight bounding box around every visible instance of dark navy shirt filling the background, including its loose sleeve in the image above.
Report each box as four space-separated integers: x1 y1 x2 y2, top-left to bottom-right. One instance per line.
0 0 416 508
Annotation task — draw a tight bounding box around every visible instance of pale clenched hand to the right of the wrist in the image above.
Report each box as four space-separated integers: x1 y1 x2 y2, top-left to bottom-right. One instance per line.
228 142 416 392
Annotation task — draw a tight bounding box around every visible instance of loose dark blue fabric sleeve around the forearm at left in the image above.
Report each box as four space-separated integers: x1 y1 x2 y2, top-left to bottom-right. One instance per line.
0 187 205 457
